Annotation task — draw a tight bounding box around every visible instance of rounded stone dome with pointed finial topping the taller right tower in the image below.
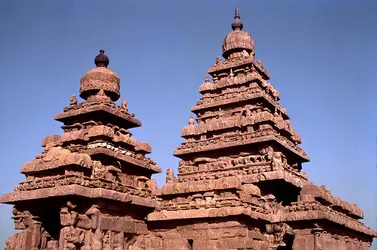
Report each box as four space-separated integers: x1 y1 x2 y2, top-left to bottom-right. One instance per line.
222 8 254 58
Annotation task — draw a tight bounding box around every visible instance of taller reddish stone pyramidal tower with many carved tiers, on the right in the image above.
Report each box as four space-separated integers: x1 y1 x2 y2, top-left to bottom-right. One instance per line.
148 9 376 250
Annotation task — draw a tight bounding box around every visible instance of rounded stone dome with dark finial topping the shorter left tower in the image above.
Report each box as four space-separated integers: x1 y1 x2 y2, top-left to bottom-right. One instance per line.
80 50 120 102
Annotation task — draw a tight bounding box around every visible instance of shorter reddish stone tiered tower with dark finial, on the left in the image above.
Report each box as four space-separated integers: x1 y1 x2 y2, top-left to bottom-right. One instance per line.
0 50 161 250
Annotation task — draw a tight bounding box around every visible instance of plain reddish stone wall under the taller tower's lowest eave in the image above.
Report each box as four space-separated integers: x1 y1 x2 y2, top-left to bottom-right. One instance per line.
137 221 268 250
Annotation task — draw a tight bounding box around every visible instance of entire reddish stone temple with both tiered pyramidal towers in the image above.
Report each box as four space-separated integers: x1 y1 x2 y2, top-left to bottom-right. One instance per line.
0 9 377 250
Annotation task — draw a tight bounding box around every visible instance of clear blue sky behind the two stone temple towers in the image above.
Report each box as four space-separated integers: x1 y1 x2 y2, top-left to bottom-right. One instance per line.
0 1 377 246
